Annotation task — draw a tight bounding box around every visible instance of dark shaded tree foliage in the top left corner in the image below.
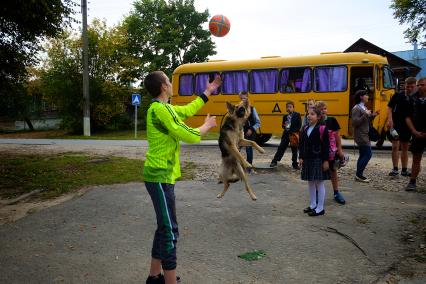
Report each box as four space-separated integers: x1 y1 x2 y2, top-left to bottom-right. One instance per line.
0 0 76 95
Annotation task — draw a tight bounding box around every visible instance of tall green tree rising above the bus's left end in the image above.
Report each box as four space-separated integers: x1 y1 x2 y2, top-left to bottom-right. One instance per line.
123 0 216 78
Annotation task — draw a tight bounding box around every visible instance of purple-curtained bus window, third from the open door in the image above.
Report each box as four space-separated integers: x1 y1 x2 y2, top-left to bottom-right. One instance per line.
250 69 278 94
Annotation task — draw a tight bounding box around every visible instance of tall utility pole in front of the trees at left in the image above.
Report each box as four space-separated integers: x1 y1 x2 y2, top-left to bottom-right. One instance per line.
81 0 90 136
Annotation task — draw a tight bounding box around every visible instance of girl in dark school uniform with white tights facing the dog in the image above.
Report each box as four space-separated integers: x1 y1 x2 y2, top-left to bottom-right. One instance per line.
299 108 330 216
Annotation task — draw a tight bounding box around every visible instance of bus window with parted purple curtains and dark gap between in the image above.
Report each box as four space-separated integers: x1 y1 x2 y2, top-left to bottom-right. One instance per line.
280 67 311 93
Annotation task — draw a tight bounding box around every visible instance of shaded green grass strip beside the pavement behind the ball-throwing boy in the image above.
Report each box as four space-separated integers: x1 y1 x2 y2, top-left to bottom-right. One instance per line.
0 153 200 198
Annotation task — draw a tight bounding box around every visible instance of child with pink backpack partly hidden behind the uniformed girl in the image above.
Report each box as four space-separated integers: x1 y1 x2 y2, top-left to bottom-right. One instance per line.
316 101 347 205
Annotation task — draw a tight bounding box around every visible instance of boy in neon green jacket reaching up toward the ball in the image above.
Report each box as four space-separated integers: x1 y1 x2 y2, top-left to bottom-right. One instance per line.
143 71 222 284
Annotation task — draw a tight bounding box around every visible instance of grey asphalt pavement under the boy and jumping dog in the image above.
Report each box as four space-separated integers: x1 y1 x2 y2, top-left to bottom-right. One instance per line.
0 171 426 284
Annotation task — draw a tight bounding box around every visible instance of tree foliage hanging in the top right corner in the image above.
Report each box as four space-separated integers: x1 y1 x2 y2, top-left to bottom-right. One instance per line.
390 0 426 46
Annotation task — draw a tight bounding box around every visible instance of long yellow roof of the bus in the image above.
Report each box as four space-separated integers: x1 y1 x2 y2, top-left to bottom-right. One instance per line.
173 52 388 74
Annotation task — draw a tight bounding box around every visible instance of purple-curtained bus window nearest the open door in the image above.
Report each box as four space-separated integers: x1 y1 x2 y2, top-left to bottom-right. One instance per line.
314 66 348 92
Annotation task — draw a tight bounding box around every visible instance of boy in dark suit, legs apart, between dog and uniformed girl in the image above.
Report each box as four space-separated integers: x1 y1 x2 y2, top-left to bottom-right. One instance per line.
270 101 302 169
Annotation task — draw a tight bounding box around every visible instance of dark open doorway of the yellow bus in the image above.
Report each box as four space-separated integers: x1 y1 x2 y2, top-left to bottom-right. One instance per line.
348 65 376 136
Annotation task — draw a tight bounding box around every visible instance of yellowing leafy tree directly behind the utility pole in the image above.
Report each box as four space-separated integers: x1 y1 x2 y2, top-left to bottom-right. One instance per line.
41 20 130 133
